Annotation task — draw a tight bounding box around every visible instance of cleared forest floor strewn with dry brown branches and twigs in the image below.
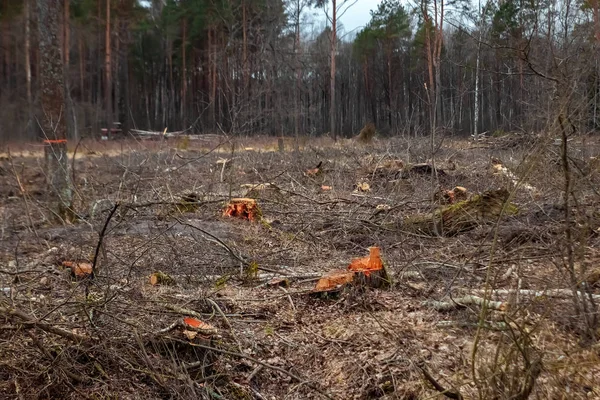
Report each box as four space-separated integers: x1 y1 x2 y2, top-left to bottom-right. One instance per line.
0 134 600 399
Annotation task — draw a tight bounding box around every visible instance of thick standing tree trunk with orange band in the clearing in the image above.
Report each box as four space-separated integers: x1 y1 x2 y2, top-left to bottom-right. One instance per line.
37 0 73 220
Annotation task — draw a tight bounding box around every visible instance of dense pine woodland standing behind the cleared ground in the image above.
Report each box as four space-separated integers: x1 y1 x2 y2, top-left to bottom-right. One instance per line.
0 0 600 139
